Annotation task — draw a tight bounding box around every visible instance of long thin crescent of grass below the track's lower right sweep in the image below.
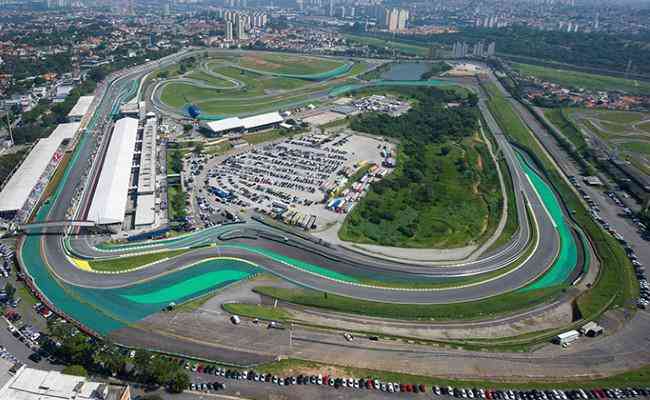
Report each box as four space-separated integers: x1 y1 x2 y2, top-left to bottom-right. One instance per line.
254 286 563 320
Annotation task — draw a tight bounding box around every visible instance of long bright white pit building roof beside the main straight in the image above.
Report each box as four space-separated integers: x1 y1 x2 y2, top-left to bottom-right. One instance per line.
88 117 138 224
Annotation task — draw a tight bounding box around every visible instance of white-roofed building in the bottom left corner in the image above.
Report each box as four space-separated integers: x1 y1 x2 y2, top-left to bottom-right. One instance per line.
0 366 131 400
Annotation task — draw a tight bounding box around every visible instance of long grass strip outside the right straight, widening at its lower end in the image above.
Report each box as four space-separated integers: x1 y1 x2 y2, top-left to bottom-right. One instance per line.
484 83 638 319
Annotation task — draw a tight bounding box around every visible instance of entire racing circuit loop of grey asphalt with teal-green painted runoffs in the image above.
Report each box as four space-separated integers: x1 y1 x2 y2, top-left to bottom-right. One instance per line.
17 49 648 382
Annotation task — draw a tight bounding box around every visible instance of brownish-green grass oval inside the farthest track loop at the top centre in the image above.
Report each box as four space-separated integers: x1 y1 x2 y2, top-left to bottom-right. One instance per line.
234 53 345 75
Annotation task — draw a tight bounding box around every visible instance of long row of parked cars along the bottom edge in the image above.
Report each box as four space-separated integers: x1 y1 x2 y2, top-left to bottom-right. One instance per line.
185 362 650 400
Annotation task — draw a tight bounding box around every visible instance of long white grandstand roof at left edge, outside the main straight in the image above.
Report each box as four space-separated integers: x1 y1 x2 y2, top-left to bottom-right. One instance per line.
0 122 79 212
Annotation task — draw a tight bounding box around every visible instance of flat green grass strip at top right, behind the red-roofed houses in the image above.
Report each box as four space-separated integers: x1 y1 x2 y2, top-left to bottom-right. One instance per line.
512 63 650 94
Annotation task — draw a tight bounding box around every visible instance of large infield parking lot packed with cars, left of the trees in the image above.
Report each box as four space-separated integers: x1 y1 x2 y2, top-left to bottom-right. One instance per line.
191 130 395 229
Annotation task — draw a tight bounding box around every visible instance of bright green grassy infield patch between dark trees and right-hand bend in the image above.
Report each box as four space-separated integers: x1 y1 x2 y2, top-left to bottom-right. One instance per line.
339 138 502 248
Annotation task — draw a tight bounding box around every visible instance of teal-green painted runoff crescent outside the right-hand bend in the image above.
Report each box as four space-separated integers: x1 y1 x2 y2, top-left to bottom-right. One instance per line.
517 154 578 291
